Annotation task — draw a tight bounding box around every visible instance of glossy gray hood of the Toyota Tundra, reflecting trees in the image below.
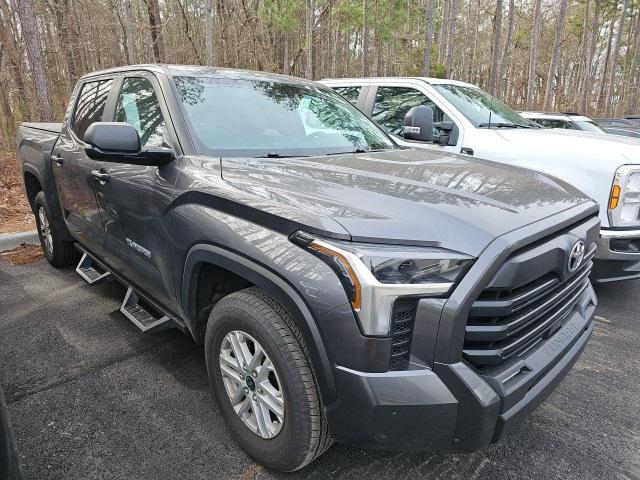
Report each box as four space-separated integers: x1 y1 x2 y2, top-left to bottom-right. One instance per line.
222 150 588 256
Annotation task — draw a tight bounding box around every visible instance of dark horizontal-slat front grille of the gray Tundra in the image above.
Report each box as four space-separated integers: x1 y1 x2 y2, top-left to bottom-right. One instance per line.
463 247 595 370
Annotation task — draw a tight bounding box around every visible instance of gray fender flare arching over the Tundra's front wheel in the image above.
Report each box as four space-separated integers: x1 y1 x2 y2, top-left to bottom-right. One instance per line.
180 244 337 407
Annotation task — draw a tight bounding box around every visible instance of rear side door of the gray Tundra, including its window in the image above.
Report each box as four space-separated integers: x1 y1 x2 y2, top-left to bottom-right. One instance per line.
51 79 112 254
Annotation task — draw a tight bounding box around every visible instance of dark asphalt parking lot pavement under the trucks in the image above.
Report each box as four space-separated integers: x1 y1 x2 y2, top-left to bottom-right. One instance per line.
0 260 640 480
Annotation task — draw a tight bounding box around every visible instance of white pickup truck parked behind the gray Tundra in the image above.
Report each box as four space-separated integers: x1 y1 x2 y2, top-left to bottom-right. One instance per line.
321 77 640 283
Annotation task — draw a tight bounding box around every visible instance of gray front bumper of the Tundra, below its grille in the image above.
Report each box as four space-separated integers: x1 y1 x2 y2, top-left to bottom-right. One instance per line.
326 287 596 451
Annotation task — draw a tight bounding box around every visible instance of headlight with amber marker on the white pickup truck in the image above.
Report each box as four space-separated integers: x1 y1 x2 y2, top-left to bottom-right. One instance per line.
609 165 640 227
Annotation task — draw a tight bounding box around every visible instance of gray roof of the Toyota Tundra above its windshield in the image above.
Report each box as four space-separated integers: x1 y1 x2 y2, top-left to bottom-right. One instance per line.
81 63 314 84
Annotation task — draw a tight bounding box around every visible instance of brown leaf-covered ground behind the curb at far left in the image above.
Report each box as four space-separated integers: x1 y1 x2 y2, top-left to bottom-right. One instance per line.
0 154 36 234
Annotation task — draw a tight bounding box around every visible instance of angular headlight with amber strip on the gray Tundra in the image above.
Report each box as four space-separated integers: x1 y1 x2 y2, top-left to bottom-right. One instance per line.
291 232 474 335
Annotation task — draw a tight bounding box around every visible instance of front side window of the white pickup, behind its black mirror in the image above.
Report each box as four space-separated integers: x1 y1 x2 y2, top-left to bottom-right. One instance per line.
371 87 444 138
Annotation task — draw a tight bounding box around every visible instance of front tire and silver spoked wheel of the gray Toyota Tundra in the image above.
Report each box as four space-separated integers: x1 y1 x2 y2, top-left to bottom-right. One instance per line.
205 287 332 472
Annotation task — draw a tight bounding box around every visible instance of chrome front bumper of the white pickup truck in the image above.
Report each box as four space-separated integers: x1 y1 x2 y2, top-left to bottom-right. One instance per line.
591 229 640 284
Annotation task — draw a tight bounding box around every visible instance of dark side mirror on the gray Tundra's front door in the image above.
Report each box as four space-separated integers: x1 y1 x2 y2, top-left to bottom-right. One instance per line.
84 122 175 167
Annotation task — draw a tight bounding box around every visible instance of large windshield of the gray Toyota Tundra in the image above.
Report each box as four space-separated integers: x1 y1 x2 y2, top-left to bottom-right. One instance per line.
173 76 396 158
